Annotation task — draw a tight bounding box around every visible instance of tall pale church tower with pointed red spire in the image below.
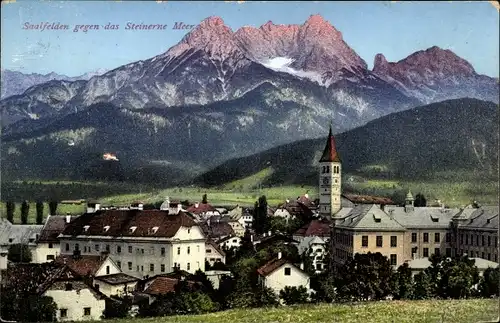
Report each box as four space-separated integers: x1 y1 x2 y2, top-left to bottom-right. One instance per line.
319 126 342 219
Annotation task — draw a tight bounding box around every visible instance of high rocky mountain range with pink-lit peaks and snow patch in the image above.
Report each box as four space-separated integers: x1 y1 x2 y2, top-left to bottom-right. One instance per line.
0 15 498 184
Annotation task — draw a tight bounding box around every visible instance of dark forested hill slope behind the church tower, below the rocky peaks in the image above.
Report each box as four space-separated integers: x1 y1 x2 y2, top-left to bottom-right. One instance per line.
194 99 499 185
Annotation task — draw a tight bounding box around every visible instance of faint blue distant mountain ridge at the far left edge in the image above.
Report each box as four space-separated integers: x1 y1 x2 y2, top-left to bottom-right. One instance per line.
1 69 106 99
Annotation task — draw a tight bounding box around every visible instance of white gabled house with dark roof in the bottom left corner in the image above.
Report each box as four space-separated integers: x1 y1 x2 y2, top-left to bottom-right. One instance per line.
5 262 106 322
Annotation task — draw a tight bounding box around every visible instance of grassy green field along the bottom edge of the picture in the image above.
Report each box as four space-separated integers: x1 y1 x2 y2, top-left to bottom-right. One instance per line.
99 300 498 323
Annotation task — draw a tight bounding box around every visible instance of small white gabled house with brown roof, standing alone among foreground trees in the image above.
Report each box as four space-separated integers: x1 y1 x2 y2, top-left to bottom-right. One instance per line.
257 253 310 295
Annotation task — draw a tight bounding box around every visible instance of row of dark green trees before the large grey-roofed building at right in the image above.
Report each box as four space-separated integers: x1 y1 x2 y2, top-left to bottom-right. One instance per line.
315 253 499 302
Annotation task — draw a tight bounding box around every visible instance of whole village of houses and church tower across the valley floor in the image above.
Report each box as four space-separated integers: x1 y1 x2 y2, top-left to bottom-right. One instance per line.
0 130 499 321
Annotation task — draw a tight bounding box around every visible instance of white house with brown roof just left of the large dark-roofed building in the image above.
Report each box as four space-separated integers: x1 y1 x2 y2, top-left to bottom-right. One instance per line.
33 215 77 263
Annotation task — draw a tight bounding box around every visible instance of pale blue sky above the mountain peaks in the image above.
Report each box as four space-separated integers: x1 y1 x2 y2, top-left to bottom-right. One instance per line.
1 0 499 77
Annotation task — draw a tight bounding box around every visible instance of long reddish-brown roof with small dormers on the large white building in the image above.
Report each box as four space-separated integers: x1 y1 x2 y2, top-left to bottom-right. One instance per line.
63 210 197 238
